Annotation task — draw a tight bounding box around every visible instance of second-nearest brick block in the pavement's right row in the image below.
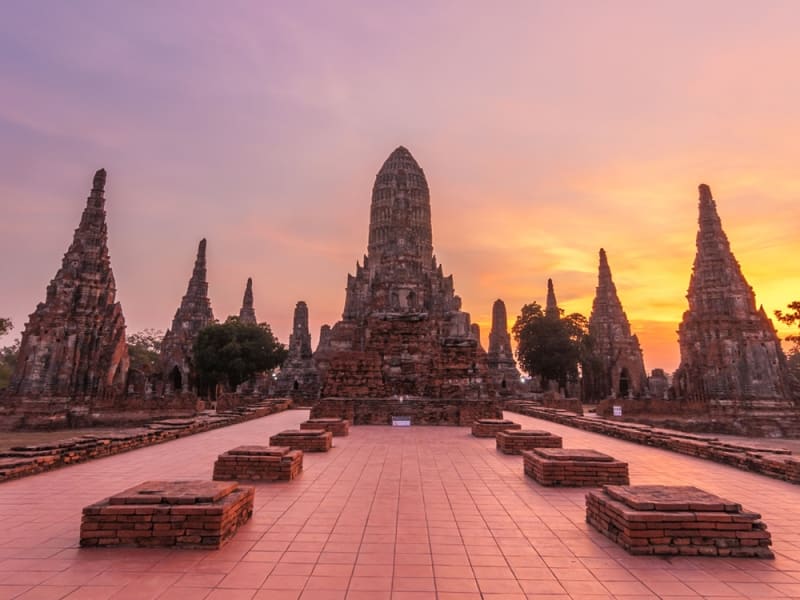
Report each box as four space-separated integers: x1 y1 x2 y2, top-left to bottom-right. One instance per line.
522 448 629 487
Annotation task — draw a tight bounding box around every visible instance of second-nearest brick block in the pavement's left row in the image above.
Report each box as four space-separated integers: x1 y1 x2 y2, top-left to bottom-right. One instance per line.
214 446 303 481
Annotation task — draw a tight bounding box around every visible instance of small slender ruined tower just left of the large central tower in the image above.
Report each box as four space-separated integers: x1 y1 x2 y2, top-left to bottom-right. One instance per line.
274 300 320 402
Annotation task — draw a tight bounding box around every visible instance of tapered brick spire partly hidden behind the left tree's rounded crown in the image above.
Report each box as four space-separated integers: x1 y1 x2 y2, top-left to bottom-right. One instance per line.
161 239 214 393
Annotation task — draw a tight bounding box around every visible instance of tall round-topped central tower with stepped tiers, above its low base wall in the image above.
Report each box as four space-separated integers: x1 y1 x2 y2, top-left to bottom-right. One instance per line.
315 146 494 398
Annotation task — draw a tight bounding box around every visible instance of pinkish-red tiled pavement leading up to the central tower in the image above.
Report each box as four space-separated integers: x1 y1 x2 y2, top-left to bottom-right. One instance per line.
0 411 800 600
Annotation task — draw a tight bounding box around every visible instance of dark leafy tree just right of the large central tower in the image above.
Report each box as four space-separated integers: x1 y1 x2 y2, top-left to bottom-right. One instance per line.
511 302 590 388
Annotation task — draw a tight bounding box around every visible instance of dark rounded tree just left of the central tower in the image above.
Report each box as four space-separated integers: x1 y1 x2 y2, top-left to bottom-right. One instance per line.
194 317 289 394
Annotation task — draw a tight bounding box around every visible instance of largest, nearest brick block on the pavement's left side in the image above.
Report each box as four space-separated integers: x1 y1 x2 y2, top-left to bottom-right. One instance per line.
80 481 255 548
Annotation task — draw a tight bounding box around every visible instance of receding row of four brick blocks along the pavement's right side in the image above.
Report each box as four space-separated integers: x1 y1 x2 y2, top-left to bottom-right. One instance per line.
473 419 773 558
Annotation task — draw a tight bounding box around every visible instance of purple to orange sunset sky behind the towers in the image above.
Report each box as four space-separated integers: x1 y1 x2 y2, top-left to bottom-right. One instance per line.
0 0 800 371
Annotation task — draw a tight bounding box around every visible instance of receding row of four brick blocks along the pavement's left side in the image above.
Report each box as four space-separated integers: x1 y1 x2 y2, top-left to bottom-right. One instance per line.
80 419 349 548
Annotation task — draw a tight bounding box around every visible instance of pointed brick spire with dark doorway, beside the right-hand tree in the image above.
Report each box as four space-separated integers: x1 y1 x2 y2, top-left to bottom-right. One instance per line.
584 248 647 400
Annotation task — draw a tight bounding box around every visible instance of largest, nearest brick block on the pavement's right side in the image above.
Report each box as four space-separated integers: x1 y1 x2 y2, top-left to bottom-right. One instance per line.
586 485 774 558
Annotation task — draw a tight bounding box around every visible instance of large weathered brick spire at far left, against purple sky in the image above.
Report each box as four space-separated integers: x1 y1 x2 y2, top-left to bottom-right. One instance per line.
9 169 129 400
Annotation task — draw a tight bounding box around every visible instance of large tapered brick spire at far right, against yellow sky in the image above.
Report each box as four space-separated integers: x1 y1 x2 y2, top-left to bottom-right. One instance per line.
675 185 789 407
